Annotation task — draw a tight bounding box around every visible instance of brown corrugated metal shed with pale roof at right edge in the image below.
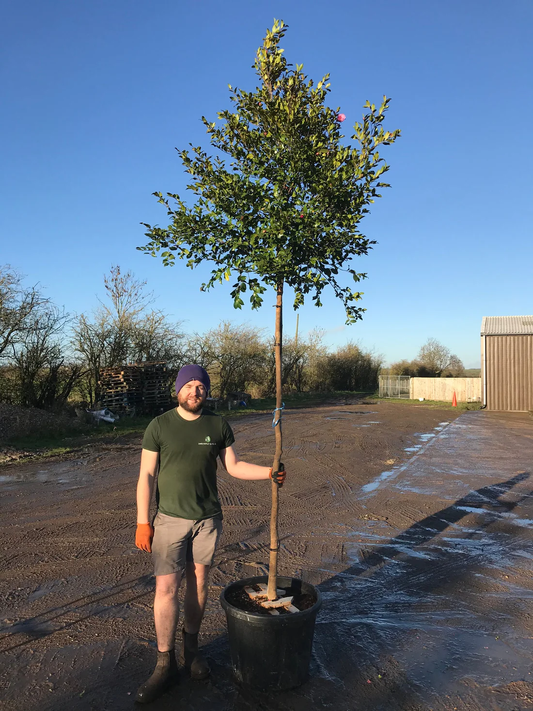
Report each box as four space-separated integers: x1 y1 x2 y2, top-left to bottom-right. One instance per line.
481 316 533 412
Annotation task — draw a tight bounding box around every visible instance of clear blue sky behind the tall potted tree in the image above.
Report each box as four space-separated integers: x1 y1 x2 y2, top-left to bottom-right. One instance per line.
0 0 533 367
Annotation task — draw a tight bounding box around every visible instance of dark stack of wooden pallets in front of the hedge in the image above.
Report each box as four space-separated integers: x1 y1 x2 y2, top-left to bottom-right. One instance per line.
99 362 172 415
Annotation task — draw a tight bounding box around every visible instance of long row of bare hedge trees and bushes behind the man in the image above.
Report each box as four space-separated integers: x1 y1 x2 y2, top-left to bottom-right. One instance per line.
0 265 382 410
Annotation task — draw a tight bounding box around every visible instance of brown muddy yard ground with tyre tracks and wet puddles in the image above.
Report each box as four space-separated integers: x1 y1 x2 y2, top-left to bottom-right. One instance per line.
0 400 533 711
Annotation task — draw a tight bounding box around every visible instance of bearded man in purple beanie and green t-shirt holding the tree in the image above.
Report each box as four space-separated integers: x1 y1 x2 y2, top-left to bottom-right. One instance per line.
135 365 285 703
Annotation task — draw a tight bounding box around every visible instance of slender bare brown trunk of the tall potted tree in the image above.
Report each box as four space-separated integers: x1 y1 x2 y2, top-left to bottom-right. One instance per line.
267 282 283 600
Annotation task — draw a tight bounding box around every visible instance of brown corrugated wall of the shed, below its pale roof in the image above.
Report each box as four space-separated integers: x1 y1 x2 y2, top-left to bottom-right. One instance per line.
486 335 533 412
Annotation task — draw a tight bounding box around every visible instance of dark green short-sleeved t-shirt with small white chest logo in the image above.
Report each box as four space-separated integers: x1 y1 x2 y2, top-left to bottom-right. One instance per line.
143 408 235 521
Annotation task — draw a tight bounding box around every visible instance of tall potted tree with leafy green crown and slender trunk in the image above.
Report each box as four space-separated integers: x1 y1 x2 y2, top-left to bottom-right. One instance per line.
139 21 399 599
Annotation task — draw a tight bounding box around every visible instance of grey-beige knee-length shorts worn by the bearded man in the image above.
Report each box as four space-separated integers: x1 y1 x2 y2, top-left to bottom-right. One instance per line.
152 512 222 575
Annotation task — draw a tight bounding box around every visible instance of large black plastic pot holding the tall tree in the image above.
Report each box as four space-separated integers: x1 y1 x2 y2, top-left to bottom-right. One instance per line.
220 576 322 691
